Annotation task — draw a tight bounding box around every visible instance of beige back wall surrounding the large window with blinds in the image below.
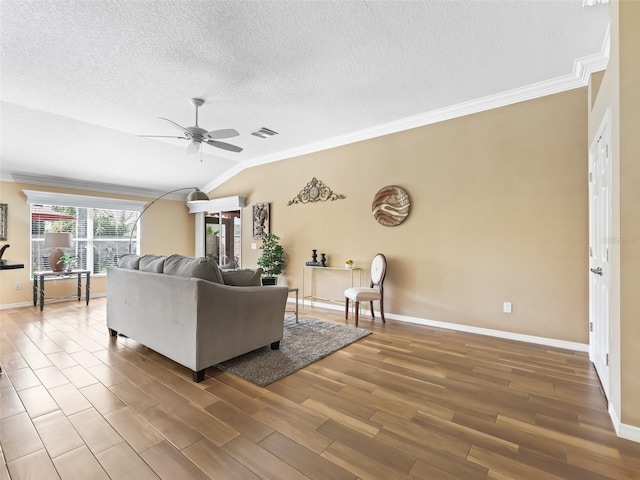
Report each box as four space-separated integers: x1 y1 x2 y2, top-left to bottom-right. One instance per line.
0 182 194 306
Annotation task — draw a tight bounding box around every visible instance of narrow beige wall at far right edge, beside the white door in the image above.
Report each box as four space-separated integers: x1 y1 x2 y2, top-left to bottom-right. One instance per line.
588 0 640 427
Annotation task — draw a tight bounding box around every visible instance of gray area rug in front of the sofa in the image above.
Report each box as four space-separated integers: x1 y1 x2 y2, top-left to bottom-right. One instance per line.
216 316 371 387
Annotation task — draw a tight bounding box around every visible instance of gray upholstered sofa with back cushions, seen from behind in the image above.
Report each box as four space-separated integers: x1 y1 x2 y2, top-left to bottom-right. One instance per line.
107 255 288 382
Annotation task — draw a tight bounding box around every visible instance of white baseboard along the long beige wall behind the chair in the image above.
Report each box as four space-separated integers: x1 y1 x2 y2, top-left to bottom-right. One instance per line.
302 300 589 352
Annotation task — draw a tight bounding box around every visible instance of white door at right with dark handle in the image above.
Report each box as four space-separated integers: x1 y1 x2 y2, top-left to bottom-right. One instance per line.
589 111 611 397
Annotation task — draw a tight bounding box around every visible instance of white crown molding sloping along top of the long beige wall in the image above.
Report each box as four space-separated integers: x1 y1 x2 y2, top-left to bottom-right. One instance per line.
203 46 609 192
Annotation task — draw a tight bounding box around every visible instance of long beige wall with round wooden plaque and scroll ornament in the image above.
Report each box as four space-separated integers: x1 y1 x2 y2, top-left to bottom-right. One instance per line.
210 88 588 343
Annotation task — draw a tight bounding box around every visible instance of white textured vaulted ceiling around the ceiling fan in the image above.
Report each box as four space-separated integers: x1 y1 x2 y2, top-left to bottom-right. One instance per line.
0 0 609 199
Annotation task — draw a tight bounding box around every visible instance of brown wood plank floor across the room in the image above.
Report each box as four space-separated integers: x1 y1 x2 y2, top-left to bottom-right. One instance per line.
0 299 640 480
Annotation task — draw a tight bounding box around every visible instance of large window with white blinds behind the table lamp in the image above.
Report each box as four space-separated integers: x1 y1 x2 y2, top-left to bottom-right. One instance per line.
25 191 144 275
